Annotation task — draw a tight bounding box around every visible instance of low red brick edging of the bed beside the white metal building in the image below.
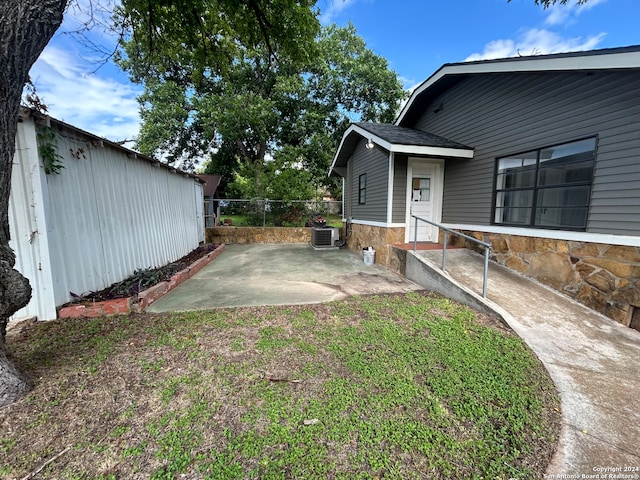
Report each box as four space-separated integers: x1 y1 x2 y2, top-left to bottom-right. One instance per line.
58 244 225 318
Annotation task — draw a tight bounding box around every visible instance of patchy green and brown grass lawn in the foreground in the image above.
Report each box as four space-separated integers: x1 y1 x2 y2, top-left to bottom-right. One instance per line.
0 293 559 479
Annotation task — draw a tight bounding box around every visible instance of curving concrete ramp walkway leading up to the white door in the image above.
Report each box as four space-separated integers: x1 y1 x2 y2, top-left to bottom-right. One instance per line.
407 249 640 479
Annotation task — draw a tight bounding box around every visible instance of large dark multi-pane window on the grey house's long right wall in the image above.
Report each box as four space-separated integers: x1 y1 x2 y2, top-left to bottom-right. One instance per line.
493 138 596 230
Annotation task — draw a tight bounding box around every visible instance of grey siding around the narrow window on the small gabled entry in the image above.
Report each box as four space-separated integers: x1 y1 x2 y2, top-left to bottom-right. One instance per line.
350 140 389 223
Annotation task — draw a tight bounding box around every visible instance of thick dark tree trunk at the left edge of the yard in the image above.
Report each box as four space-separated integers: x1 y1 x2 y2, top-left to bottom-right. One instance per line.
0 0 68 407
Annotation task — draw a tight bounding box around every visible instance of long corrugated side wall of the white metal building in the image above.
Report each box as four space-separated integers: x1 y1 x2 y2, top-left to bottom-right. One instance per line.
12 119 200 319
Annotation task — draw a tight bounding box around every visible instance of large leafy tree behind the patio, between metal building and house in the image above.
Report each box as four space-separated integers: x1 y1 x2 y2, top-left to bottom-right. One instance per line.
123 19 404 198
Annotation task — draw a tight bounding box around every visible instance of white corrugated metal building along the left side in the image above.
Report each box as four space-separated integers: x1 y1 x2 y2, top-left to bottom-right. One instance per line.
9 109 204 320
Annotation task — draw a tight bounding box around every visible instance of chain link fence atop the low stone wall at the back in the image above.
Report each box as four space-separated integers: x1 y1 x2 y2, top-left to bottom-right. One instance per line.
204 199 342 227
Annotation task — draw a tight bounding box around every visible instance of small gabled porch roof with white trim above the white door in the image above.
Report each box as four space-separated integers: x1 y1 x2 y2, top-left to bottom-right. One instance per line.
329 122 473 177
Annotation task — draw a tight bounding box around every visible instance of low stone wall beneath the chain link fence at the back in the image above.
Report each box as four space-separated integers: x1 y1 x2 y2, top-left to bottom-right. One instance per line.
205 227 311 245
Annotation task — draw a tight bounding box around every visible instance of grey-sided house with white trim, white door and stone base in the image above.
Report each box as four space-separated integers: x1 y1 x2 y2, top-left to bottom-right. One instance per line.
330 46 640 325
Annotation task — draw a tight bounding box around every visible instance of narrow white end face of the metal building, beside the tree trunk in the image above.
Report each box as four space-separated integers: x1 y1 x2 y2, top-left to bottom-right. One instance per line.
9 119 56 319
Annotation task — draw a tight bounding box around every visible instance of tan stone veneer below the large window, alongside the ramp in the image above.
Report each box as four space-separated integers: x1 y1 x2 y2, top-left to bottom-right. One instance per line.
449 231 640 330
